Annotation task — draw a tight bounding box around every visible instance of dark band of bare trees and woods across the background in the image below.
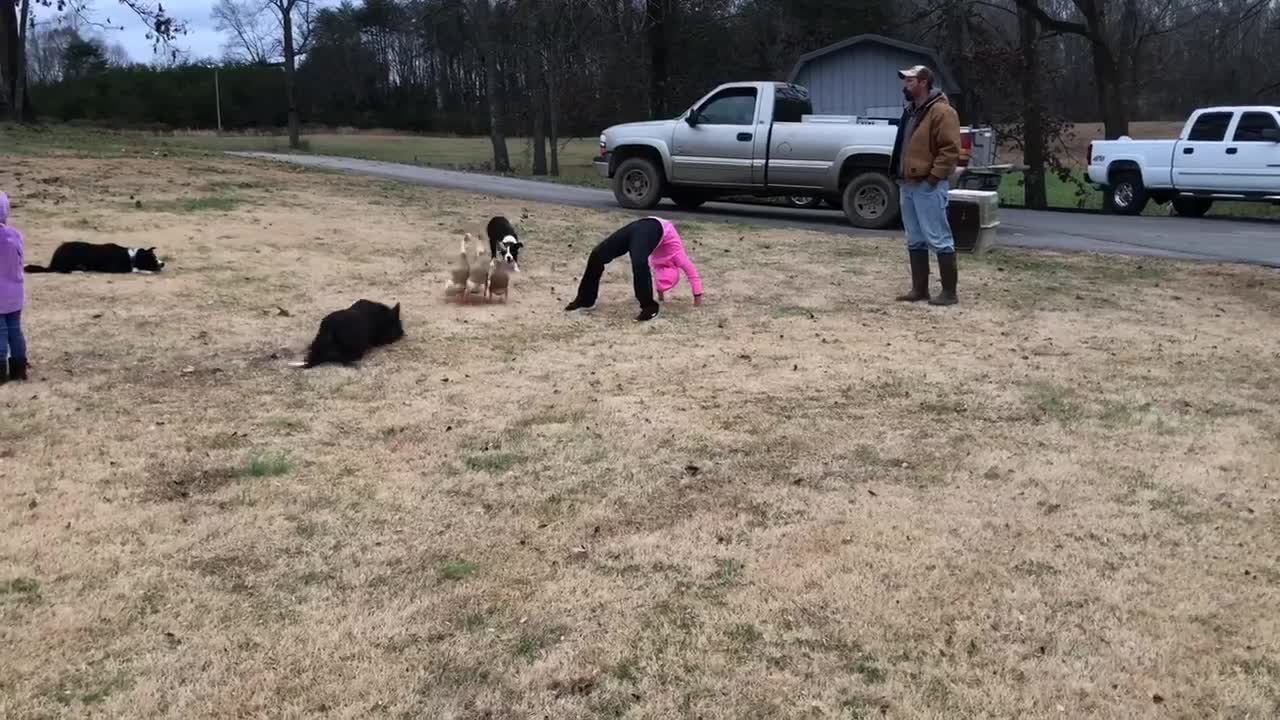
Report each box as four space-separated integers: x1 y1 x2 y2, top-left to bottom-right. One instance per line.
0 0 1280 199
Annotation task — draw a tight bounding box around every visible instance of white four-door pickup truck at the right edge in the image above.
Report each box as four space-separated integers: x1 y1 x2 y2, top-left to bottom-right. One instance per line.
1089 106 1280 218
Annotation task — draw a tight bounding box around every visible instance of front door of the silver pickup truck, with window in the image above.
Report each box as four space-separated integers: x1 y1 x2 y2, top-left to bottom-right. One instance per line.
671 87 758 186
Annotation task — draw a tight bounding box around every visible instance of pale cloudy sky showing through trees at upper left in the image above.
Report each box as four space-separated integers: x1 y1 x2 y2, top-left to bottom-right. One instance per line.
32 0 232 63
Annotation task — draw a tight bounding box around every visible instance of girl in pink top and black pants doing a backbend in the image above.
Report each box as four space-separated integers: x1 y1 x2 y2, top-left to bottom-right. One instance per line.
564 218 703 322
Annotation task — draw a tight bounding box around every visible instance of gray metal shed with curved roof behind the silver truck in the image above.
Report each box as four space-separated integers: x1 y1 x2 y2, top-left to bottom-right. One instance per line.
787 33 963 118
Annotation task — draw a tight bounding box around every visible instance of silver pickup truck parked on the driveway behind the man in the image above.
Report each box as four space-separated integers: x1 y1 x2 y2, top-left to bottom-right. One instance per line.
594 82 1002 229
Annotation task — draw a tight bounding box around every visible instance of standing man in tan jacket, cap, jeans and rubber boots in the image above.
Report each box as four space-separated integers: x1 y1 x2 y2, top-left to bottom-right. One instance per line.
890 65 960 305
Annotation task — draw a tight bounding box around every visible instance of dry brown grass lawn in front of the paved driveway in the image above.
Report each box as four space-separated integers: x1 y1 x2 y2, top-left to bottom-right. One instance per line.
0 142 1280 720
